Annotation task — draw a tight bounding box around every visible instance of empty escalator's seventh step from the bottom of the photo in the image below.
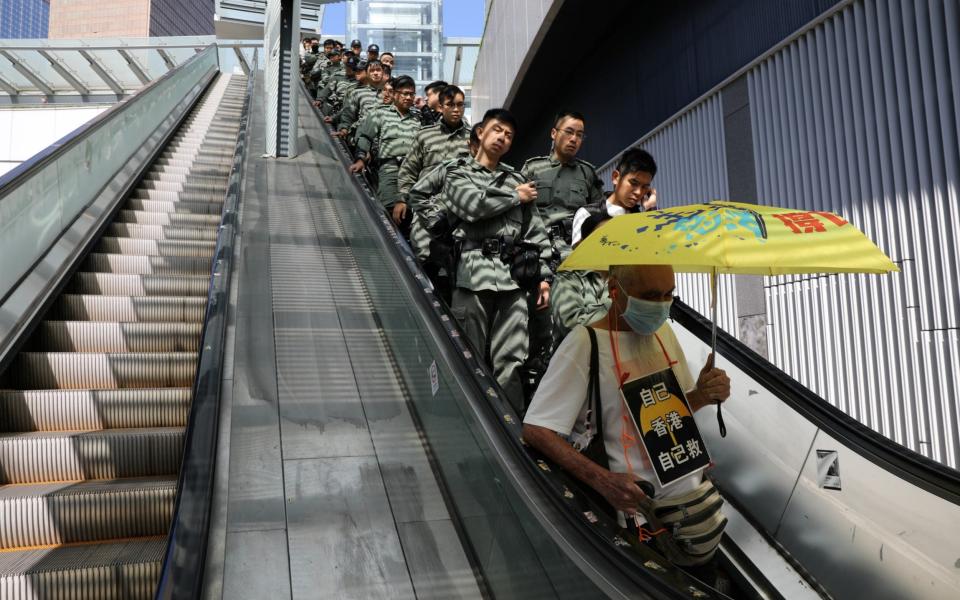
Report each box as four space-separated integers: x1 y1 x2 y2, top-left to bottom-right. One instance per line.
47 294 207 323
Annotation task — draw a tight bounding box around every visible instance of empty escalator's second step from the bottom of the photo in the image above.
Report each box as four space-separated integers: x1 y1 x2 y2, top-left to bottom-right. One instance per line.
0 475 177 550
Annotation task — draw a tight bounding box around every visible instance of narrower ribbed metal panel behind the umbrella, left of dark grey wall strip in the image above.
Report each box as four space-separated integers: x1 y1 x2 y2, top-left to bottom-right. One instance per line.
600 94 737 334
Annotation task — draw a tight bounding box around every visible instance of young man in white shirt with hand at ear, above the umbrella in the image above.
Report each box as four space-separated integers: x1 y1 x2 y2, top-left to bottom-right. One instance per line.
571 148 657 246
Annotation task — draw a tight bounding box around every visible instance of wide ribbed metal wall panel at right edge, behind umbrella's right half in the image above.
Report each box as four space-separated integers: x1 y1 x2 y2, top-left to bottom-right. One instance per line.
748 0 960 468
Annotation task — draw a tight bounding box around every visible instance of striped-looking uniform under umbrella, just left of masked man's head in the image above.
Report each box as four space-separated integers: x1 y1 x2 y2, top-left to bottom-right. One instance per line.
550 271 610 345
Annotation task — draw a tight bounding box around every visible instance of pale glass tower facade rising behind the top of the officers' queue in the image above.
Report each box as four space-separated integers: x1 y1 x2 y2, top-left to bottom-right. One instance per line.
347 0 443 88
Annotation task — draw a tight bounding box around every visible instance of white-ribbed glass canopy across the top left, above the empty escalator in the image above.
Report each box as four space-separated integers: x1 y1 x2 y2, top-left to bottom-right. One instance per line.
0 36 259 104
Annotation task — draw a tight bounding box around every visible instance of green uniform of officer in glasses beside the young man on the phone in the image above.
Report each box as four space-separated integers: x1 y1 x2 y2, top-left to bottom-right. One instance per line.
521 155 604 369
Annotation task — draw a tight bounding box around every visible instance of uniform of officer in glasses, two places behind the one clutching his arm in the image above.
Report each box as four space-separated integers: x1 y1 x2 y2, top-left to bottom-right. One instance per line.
356 106 420 209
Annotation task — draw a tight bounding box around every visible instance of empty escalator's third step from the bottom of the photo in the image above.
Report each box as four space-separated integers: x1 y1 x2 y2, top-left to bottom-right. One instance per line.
0 427 184 484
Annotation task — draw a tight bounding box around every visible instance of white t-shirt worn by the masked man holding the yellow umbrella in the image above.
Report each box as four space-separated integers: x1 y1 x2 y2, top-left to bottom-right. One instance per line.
523 323 701 498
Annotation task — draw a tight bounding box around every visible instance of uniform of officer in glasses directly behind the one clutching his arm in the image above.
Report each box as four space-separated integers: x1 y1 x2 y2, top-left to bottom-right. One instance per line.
398 119 470 260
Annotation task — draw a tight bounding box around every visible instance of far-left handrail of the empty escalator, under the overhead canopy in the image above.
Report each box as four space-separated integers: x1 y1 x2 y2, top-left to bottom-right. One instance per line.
0 43 217 195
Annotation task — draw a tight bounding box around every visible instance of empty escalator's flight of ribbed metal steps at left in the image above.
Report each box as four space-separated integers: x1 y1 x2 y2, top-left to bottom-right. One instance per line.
0 70 247 600
